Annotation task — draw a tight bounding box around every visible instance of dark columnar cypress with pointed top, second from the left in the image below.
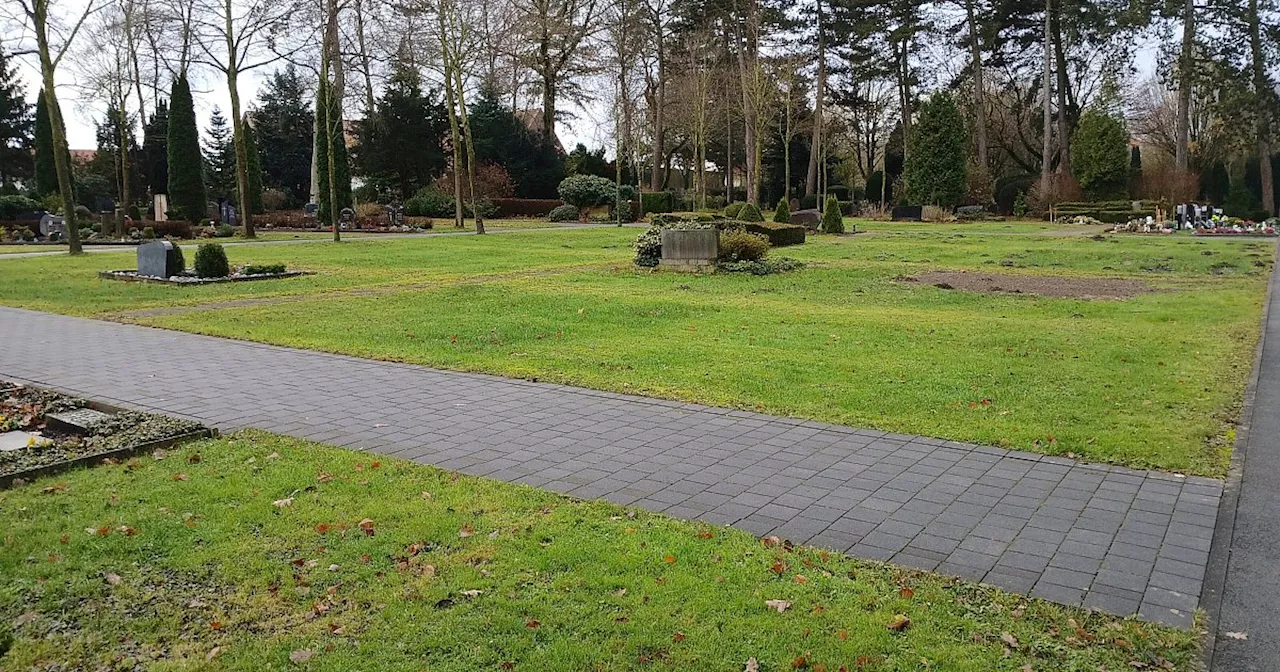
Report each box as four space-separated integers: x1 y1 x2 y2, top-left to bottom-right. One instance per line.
166 73 207 223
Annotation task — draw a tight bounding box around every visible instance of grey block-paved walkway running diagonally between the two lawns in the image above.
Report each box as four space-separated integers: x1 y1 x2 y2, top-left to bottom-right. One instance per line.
0 308 1221 626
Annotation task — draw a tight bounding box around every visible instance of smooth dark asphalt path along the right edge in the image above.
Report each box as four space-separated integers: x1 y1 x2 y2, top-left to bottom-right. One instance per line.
1206 253 1280 672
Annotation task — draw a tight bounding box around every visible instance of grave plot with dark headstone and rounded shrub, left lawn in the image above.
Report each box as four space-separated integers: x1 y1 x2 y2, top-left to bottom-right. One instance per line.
99 241 312 284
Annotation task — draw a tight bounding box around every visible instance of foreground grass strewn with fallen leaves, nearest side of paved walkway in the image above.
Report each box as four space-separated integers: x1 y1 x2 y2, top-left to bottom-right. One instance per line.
0 433 1196 672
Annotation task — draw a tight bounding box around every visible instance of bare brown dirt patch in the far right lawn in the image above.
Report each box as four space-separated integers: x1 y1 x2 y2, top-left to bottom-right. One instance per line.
900 270 1155 298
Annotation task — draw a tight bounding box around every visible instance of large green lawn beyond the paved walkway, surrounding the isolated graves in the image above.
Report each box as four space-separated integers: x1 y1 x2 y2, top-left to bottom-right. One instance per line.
0 223 1274 476
